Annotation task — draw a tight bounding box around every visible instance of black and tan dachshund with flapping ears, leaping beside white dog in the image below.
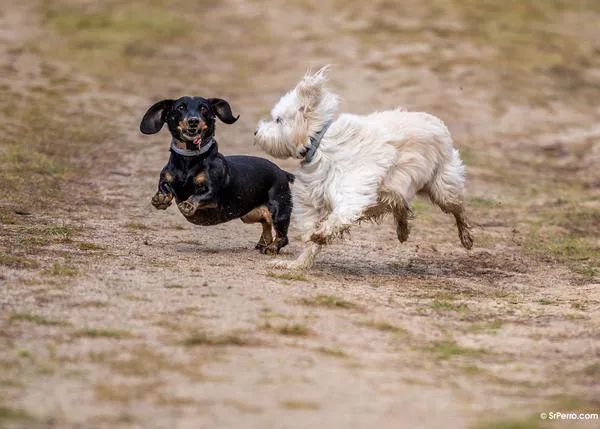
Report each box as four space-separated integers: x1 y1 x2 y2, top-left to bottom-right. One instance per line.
140 97 294 253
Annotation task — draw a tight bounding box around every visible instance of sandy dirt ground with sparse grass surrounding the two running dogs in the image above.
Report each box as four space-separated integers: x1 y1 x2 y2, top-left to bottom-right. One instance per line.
0 0 600 429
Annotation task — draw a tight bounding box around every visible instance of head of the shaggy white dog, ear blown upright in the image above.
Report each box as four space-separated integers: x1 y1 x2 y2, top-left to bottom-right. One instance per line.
254 66 339 158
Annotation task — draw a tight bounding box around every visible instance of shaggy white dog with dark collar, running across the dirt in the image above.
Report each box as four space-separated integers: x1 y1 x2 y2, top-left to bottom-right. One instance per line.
255 67 473 269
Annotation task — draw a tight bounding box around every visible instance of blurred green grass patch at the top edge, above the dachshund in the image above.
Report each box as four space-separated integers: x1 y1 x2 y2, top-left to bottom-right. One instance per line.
42 0 192 80
